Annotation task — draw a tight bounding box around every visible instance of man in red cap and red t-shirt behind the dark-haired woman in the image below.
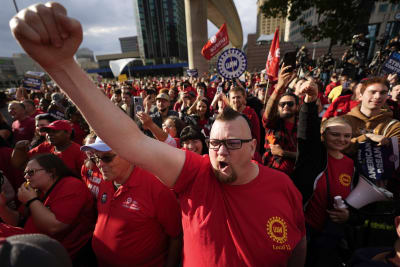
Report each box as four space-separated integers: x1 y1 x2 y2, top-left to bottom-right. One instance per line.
11 120 86 176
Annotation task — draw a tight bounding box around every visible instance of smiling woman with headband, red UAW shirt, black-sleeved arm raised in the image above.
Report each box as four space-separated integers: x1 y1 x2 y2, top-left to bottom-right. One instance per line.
292 81 354 266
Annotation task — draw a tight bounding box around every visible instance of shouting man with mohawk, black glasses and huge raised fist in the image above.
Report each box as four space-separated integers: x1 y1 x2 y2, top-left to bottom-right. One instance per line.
10 2 306 267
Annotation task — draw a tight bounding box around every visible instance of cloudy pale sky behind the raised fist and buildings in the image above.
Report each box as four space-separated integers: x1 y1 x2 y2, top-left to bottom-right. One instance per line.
0 0 257 57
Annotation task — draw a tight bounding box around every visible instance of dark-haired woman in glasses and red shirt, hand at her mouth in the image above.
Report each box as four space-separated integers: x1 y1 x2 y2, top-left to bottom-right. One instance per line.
0 154 96 263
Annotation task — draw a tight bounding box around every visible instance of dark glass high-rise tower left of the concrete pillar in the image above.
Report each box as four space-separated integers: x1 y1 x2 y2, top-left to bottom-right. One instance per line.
133 0 187 64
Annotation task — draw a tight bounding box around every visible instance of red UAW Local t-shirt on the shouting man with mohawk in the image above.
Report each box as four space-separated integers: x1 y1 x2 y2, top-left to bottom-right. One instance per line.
174 151 305 267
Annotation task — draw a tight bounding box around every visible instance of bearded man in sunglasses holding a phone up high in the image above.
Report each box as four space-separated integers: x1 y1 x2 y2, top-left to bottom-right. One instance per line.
262 67 299 175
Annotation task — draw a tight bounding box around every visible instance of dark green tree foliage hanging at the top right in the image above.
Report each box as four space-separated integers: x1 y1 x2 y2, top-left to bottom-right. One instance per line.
261 0 400 44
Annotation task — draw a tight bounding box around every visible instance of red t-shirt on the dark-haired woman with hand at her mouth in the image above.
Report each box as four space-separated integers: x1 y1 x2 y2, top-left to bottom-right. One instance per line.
24 177 96 258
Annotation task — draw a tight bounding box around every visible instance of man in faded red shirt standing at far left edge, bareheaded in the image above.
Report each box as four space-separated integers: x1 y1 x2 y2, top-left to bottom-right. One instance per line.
8 101 35 142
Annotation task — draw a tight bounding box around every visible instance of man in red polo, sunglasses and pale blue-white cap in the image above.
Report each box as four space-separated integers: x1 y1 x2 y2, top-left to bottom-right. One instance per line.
81 137 182 267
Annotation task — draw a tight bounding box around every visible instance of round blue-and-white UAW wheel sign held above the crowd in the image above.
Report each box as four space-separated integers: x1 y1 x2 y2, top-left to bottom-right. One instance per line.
217 48 247 79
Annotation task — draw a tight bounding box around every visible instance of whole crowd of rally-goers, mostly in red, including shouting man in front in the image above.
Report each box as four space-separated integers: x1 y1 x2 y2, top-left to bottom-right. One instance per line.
0 2 400 267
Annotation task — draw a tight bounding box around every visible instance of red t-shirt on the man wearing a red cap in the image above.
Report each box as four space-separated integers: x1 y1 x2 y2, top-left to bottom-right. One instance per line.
28 141 86 175
